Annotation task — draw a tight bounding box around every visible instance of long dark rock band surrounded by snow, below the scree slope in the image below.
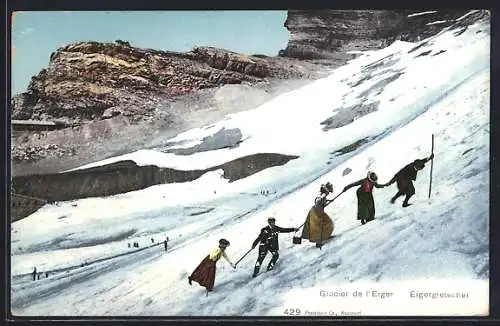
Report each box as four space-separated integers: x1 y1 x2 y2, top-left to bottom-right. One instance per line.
11 153 298 221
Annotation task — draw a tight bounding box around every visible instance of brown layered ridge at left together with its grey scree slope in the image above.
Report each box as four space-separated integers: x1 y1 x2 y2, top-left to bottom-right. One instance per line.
11 41 320 171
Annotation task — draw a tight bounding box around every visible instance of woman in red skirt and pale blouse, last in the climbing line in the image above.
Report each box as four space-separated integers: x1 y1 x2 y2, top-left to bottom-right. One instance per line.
188 239 236 291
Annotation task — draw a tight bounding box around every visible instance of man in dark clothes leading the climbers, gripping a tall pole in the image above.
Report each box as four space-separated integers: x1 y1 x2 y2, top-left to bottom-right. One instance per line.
384 154 434 207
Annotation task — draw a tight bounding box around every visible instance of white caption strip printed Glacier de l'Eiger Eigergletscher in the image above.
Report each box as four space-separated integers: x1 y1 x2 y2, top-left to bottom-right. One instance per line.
270 279 489 317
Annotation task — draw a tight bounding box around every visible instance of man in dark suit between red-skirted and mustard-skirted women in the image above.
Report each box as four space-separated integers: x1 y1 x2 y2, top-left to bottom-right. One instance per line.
252 217 299 277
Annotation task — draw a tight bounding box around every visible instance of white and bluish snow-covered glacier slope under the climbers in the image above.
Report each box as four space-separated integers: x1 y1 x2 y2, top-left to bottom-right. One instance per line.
11 14 490 316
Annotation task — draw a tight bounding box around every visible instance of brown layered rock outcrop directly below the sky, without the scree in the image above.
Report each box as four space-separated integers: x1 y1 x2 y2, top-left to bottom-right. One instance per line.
12 41 316 123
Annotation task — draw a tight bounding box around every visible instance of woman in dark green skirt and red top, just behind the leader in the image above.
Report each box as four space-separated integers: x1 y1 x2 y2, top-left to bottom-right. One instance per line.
344 171 386 224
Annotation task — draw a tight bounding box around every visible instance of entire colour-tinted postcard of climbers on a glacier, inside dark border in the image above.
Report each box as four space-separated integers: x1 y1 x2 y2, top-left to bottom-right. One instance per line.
10 9 491 320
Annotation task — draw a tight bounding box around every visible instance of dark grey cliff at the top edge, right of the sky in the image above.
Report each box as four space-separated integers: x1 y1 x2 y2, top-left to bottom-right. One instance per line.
280 10 468 64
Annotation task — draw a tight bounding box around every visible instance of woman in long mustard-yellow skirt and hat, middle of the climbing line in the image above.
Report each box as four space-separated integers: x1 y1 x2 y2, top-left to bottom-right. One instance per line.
301 182 334 248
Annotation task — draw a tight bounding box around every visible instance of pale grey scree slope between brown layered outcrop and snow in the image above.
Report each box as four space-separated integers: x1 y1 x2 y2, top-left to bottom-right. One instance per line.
11 79 320 176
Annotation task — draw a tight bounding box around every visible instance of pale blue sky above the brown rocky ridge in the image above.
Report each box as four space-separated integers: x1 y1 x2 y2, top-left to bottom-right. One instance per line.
12 11 289 94
